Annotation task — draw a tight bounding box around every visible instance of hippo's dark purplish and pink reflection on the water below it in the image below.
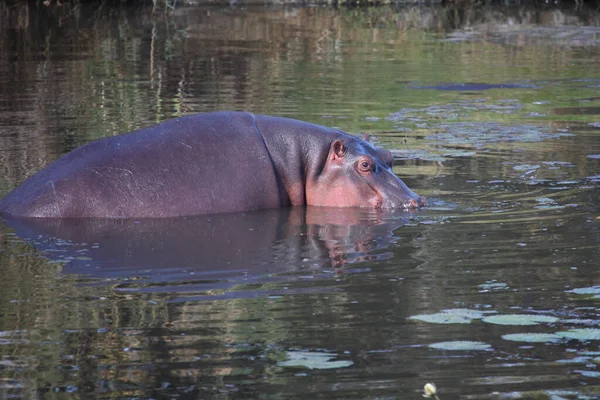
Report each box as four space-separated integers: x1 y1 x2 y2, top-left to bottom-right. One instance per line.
5 207 410 295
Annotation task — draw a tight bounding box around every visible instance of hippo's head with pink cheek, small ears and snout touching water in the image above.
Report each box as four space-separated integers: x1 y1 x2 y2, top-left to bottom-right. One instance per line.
306 138 426 209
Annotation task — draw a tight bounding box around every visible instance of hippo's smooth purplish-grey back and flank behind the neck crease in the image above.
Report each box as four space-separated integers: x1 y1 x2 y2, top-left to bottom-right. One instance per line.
0 112 286 218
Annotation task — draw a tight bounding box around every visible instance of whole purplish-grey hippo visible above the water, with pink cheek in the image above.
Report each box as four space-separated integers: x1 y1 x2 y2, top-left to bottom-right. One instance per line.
0 112 425 218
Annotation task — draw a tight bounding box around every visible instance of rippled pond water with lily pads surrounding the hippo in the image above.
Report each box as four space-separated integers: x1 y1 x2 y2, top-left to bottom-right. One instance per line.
0 4 600 400
